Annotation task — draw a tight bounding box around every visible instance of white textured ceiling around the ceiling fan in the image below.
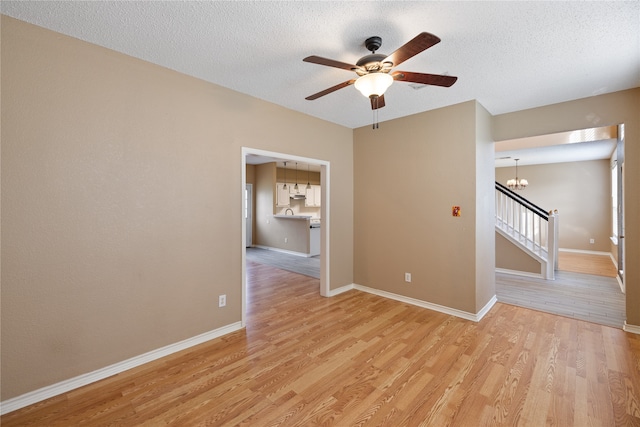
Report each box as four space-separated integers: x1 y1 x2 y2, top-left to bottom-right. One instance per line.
5 0 640 128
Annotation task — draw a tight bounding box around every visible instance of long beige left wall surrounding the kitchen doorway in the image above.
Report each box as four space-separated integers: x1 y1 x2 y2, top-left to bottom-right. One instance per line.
0 16 353 400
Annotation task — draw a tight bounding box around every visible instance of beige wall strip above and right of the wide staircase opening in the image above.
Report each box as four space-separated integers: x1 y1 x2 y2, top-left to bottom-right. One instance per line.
493 88 640 326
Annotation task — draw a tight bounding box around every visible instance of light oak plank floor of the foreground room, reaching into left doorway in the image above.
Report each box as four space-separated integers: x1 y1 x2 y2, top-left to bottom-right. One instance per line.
1 262 640 427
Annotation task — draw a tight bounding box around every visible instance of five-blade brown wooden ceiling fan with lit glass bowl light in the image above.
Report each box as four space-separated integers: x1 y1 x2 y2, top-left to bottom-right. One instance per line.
303 32 458 128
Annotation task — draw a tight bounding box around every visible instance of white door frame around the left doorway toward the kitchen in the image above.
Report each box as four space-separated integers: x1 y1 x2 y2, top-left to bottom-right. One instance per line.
240 147 331 327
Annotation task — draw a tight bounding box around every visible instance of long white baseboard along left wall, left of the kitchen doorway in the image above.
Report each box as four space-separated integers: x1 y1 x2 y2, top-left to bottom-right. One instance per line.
0 322 242 415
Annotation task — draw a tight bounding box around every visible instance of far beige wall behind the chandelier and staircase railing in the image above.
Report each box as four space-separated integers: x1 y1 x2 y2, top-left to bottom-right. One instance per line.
496 160 611 252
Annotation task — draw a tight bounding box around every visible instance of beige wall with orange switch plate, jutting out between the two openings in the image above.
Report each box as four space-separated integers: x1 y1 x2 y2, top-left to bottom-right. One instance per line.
354 101 495 313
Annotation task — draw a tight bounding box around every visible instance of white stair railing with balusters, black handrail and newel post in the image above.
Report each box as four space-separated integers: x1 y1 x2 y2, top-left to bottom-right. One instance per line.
495 182 558 280
